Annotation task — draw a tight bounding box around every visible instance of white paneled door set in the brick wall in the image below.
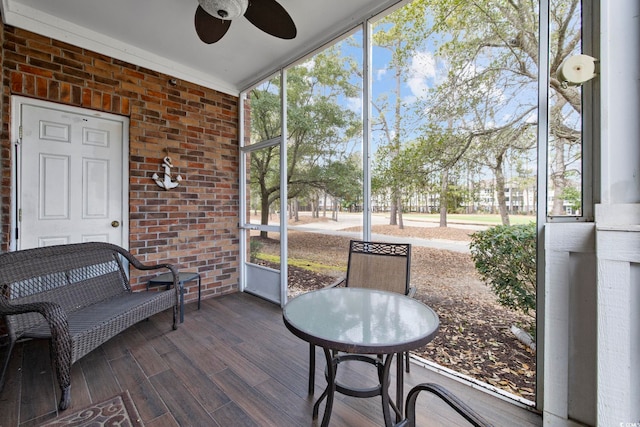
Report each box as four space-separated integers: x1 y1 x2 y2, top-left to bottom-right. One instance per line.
14 99 128 249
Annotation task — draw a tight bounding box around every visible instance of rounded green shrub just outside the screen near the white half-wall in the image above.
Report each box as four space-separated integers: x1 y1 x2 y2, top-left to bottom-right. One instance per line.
470 223 536 317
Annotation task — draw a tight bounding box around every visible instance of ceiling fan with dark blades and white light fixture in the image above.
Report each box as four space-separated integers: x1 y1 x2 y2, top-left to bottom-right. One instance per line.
195 0 297 44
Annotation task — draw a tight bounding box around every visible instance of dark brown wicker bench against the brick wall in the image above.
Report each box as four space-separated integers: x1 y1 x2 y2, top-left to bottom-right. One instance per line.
0 242 180 410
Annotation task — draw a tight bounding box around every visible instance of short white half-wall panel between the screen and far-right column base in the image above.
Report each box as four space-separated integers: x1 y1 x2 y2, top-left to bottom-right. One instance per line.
539 223 597 427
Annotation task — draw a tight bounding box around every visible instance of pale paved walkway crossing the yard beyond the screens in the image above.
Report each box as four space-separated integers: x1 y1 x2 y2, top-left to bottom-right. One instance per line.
289 213 486 253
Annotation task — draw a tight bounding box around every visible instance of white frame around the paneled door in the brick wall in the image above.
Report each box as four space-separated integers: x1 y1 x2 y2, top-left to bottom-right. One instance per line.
9 95 129 251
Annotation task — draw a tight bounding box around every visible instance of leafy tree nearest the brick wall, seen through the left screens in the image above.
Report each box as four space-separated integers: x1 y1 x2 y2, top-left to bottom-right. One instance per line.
250 47 361 237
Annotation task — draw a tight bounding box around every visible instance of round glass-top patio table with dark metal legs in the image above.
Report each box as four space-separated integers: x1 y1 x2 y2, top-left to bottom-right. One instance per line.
282 287 439 427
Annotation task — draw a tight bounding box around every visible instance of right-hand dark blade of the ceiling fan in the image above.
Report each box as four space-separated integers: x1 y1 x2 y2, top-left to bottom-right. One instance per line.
244 0 298 39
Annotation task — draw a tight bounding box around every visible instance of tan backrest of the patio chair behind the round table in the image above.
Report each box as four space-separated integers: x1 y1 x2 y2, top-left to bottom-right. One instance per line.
345 240 411 295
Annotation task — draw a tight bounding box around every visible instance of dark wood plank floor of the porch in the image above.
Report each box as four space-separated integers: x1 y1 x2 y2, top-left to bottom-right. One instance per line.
0 293 542 427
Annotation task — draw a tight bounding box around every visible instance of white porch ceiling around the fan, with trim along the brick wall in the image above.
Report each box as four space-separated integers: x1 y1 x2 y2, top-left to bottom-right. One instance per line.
2 0 399 95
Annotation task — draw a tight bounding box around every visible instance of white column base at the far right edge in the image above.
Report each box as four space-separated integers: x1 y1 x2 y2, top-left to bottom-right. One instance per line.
596 204 640 426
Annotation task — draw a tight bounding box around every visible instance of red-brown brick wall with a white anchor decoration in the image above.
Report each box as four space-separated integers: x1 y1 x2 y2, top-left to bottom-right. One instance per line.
0 26 239 300
